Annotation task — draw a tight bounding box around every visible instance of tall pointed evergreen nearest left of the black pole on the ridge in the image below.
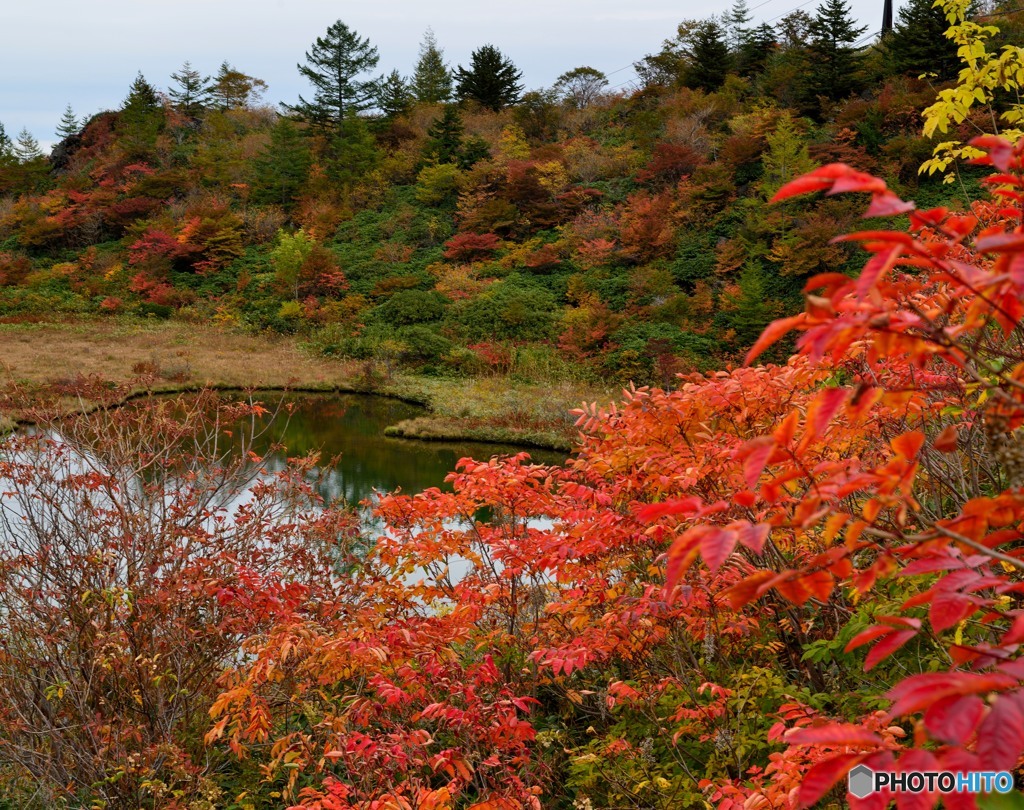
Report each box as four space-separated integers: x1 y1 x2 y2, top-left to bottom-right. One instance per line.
803 0 867 112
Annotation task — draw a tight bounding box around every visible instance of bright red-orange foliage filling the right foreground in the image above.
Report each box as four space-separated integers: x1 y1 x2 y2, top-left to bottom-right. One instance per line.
197 138 1024 810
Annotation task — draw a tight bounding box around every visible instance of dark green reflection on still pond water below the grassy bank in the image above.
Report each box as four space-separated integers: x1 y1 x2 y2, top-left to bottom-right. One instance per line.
240 394 566 504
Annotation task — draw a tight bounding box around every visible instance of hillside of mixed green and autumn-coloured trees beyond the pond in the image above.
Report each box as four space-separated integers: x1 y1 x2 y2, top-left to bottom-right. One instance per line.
0 0 1016 384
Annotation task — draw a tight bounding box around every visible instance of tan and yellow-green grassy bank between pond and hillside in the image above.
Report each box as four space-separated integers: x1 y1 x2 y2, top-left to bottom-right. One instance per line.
0 319 610 450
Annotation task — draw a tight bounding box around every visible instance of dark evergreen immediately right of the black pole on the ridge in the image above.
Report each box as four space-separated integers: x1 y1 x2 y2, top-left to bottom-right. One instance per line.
882 0 959 81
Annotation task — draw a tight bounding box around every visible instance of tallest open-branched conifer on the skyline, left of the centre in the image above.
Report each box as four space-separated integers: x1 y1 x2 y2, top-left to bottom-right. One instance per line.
290 19 380 127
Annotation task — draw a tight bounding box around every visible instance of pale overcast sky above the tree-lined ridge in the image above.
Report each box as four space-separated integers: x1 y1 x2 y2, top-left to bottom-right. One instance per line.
0 0 884 144
